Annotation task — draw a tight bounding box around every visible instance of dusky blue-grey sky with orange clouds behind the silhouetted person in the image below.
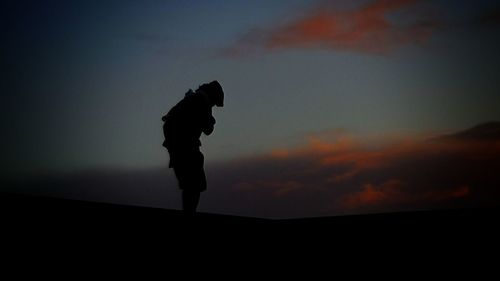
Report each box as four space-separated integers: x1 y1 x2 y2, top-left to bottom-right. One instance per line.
0 0 500 217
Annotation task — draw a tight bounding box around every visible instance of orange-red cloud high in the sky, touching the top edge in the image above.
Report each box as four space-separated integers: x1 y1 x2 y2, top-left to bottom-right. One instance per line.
224 0 437 55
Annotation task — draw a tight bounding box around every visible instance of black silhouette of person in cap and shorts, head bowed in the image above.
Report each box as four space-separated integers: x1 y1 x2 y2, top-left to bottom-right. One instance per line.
162 81 224 214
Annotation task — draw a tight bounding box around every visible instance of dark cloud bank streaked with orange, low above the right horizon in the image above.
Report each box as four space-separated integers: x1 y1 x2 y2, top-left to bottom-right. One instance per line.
229 123 500 213
